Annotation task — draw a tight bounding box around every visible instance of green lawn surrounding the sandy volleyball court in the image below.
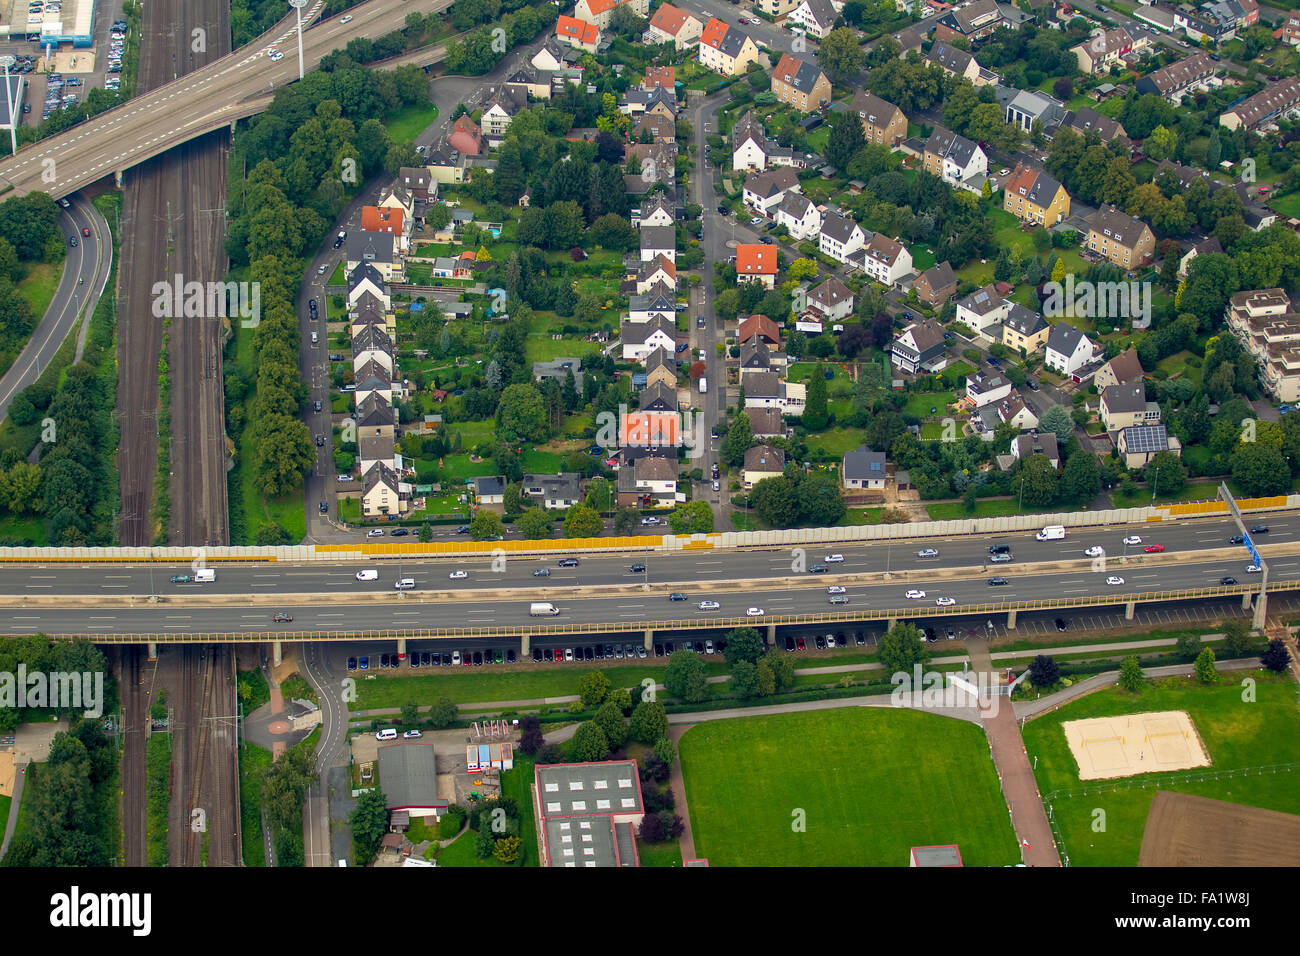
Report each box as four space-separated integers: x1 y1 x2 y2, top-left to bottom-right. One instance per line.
1024 671 1300 866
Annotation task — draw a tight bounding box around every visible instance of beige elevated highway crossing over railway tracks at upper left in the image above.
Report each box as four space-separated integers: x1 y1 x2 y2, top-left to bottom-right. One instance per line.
0 0 451 198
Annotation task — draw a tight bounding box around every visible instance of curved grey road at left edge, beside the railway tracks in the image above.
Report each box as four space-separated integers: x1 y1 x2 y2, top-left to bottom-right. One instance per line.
0 194 113 420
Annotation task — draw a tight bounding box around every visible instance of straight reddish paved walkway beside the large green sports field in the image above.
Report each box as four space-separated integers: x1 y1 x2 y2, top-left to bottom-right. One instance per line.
969 643 1061 866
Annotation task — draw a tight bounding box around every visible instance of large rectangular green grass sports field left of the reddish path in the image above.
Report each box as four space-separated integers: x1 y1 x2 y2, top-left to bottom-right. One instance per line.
680 708 1021 866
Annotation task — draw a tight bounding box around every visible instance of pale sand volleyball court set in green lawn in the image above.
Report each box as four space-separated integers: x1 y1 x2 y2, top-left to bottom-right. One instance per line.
1061 710 1210 780
